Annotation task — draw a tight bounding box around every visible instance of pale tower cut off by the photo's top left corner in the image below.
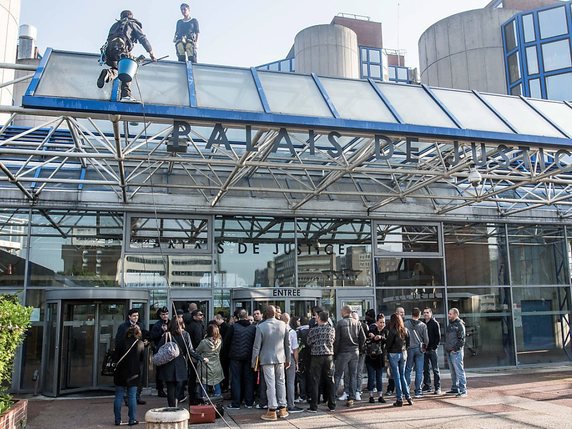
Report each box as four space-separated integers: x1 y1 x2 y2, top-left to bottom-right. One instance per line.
0 0 20 125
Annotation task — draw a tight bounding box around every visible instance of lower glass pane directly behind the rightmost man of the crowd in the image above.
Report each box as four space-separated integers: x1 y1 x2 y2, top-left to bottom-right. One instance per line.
447 287 514 368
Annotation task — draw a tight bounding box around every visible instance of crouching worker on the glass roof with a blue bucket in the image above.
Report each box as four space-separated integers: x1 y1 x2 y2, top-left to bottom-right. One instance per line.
97 10 156 102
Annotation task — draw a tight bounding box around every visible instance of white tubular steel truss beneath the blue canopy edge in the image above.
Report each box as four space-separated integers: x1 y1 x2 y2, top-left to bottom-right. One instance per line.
0 108 572 219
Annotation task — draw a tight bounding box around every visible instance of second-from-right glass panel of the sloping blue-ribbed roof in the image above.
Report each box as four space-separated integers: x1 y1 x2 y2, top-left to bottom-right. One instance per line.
482 94 564 137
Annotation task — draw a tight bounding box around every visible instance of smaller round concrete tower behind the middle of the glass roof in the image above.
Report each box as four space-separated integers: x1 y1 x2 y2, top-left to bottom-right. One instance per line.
294 24 360 79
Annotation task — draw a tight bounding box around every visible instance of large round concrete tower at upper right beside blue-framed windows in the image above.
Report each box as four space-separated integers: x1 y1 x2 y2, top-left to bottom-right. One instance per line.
419 8 518 94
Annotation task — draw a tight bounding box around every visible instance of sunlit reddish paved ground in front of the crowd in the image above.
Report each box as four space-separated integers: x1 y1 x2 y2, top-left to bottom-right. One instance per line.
23 365 572 429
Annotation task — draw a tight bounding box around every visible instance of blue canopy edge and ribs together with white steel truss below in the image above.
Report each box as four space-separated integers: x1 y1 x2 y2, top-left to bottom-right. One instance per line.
0 51 572 221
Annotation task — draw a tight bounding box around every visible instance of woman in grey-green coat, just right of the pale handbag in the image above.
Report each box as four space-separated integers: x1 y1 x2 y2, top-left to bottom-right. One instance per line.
197 324 224 398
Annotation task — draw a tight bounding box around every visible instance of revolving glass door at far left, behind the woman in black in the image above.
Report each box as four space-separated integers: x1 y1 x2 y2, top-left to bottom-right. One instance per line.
41 289 148 396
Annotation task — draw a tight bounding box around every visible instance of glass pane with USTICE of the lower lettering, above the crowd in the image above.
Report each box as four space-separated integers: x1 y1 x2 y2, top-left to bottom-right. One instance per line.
297 218 372 287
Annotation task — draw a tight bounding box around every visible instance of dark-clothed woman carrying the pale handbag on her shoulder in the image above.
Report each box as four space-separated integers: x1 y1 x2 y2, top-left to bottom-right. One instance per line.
157 317 208 407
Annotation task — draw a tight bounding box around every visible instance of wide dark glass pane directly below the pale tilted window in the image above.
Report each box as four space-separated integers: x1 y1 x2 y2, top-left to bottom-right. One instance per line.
375 257 445 290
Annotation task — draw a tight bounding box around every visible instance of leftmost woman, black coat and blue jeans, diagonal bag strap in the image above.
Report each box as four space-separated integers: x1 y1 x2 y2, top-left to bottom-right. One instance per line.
113 325 145 426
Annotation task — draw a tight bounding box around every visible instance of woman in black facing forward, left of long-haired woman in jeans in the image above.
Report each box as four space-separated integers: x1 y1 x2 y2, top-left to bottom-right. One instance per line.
365 313 389 404
